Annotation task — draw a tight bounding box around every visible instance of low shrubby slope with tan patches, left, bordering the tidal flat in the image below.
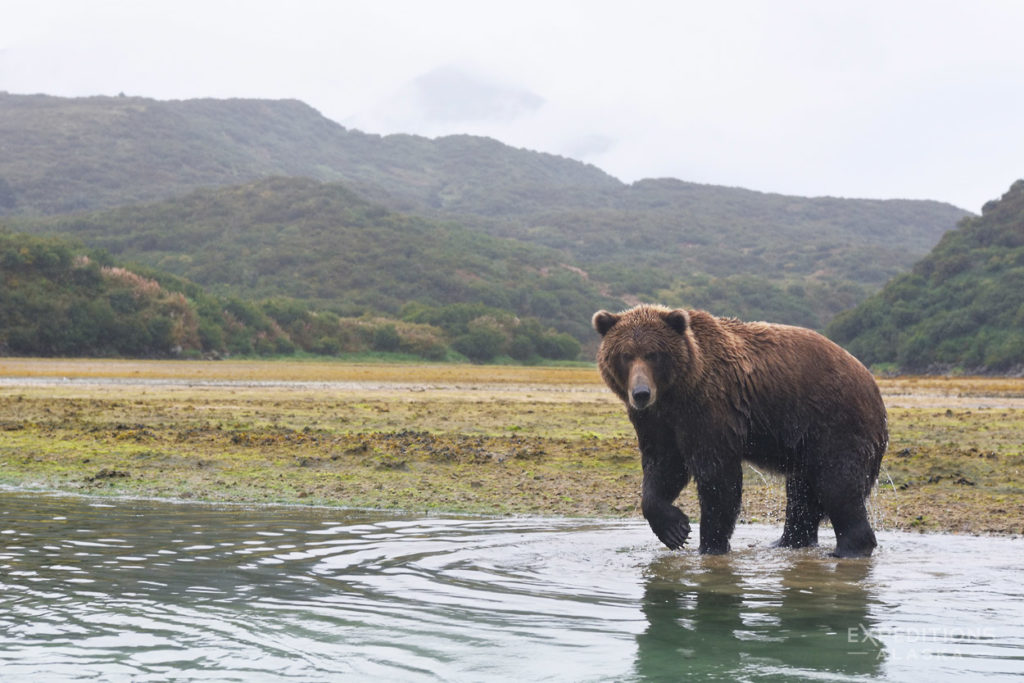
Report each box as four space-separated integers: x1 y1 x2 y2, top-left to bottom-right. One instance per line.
0 232 581 361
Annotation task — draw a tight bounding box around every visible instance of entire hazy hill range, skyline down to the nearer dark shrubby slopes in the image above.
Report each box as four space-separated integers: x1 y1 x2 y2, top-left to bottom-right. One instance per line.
0 93 968 358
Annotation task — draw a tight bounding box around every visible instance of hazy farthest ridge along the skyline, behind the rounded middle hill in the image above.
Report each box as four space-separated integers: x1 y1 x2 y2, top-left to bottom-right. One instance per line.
0 93 966 328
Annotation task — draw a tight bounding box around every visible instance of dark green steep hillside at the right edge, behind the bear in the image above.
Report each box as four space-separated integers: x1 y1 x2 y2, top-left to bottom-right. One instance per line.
828 180 1024 373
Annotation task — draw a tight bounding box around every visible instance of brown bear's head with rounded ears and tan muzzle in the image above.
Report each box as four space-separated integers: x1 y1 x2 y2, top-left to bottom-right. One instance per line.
593 304 698 411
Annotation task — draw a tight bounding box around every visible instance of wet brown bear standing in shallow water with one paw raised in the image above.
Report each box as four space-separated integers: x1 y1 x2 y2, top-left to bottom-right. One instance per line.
593 305 889 557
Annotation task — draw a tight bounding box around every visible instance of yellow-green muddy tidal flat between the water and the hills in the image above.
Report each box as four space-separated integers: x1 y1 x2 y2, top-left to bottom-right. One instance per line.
0 358 1024 535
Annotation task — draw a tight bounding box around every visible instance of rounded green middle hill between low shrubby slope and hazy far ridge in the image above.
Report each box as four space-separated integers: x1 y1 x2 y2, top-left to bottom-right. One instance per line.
7 178 624 339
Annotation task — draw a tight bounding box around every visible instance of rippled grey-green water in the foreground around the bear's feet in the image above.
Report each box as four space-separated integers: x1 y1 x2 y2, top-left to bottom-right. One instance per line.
0 492 1024 683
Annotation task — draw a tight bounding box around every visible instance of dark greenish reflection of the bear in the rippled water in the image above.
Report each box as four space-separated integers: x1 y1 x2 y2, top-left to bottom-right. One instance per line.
636 549 884 680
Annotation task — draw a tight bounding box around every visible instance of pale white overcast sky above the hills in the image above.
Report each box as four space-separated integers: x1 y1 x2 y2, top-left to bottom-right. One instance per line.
0 0 1024 211
